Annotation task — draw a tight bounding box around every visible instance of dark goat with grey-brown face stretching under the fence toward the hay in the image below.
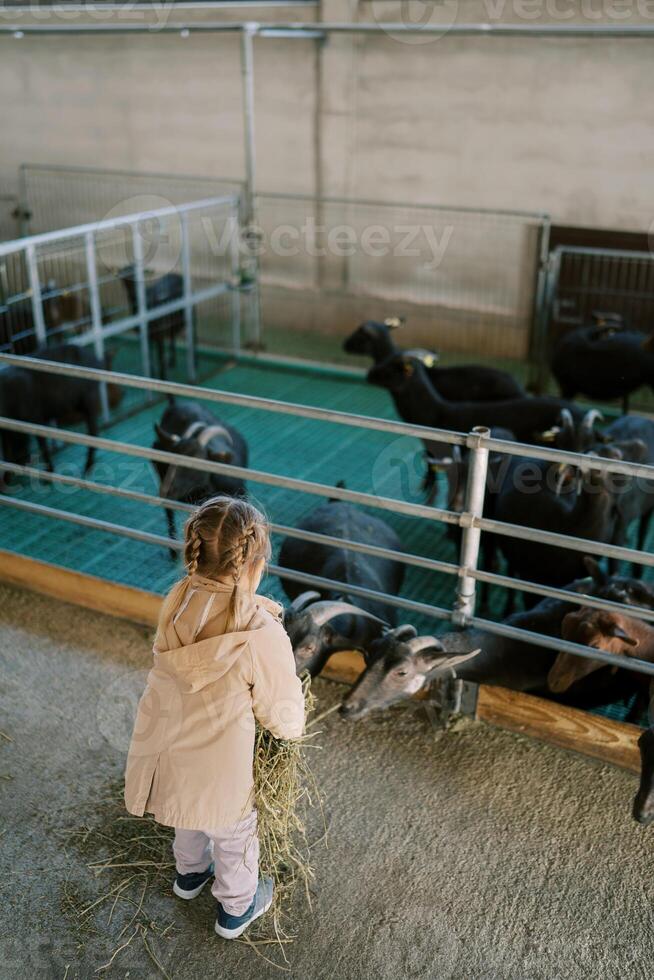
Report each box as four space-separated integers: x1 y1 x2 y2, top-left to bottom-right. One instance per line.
341 559 654 719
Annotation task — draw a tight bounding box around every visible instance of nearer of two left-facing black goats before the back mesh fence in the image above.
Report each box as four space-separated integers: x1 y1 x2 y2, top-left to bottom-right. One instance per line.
368 354 583 442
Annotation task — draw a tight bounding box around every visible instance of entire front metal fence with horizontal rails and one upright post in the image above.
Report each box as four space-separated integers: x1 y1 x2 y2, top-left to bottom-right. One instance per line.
0 354 654 675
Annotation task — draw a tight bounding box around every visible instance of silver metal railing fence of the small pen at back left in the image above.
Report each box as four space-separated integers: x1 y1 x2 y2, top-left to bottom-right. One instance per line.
0 196 240 416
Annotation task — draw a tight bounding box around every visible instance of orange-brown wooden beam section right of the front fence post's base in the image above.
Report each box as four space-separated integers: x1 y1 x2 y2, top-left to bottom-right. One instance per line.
477 684 643 772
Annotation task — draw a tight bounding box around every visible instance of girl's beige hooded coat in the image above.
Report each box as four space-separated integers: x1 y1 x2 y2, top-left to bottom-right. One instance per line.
125 575 304 830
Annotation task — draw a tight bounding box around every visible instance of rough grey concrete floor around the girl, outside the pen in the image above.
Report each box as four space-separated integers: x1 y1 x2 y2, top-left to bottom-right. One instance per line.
0 586 654 980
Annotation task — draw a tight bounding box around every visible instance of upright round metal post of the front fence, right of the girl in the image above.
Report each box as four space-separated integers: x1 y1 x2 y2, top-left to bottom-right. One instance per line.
452 425 490 626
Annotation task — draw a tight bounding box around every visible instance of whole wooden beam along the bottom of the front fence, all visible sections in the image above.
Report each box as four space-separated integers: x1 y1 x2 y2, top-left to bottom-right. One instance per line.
0 550 642 772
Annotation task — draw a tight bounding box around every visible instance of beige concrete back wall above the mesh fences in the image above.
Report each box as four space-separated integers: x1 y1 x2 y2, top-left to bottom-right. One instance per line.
0 0 654 230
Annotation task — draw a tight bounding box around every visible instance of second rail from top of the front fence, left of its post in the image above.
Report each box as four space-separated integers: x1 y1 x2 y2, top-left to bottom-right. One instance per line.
0 416 459 524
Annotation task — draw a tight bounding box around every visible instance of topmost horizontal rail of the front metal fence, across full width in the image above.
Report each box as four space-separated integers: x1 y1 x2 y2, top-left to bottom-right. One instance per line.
6 356 654 489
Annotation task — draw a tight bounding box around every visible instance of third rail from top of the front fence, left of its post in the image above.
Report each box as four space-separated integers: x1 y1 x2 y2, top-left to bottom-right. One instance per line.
0 461 462 580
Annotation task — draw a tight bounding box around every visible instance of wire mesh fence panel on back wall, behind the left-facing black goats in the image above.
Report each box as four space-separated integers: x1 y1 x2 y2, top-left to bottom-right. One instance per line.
256 194 549 361
